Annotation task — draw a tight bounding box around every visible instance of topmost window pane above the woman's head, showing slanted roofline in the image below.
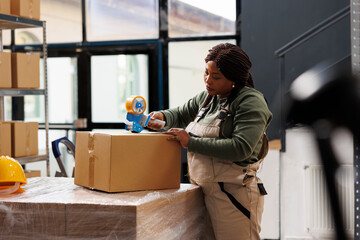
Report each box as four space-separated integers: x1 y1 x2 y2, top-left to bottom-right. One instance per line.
168 0 236 37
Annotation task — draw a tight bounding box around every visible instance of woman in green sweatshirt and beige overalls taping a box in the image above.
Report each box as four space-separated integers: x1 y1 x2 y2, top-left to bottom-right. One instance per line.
149 43 272 240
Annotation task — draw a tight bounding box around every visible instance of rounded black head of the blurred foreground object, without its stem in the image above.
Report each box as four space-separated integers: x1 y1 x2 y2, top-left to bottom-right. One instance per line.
285 63 360 132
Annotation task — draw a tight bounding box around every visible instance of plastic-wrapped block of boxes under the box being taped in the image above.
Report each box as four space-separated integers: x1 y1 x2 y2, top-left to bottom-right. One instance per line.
0 178 213 240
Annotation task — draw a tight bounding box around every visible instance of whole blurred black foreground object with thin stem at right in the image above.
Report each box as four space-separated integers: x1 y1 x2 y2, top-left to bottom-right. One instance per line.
284 63 360 240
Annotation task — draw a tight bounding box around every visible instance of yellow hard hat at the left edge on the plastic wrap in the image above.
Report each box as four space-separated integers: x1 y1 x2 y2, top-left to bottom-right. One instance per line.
0 156 27 194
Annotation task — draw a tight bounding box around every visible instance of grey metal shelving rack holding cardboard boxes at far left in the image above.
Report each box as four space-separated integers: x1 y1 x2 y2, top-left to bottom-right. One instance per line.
0 14 50 176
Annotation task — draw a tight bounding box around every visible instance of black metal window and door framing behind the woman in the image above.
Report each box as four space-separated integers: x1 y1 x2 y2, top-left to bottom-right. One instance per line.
10 0 241 131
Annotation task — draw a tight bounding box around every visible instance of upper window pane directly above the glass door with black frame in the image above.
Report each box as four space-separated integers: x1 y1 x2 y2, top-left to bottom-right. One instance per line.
86 0 159 41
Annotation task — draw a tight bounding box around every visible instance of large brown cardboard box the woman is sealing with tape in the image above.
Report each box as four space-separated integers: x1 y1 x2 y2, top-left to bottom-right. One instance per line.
75 132 181 192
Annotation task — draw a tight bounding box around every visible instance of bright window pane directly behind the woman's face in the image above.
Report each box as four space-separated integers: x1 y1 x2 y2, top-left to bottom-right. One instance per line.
169 40 235 107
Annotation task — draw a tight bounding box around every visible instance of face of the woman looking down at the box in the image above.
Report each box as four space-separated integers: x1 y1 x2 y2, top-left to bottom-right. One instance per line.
204 61 234 98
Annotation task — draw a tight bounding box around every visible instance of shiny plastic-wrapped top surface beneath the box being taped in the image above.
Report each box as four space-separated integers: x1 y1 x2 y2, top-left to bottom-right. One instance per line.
0 177 200 206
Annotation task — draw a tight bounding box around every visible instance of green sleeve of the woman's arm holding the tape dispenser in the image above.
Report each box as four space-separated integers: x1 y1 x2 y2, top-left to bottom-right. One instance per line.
160 92 207 130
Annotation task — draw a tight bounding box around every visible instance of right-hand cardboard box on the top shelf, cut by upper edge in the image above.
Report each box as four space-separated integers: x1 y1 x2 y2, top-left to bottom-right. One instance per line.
11 0 40 20
